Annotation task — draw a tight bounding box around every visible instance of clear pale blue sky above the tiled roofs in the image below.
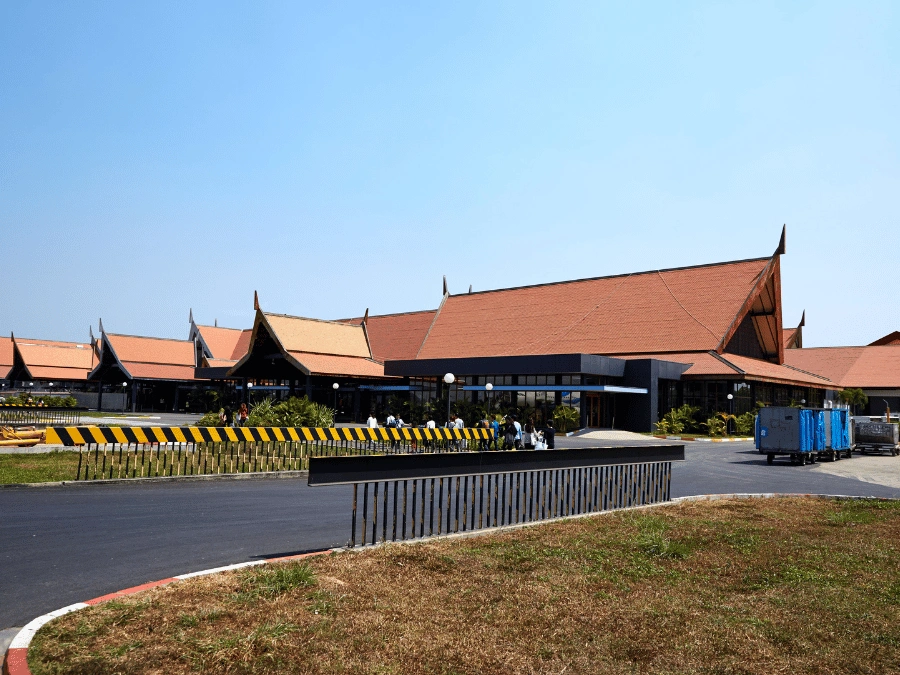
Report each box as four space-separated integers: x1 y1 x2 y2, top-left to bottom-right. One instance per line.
0 1 900 346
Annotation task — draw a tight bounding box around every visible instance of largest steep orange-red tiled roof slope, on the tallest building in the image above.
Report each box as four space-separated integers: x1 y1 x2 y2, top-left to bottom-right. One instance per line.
417 258 772 359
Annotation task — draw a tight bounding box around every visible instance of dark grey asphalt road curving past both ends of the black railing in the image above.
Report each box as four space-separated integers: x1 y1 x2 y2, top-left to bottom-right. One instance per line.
0 443 900 629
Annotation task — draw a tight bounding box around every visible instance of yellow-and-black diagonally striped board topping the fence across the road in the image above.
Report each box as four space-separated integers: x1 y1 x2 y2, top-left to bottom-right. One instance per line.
45 426 494 446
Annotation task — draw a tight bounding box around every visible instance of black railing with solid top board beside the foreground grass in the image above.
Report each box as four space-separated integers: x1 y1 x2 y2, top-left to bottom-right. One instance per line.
309 445 684 547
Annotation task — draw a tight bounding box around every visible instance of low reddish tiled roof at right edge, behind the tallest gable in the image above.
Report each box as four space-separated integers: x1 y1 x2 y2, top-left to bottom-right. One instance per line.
785 345 900 389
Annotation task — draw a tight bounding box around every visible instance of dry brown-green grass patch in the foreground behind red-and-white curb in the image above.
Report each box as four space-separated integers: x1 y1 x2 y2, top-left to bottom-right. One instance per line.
29 499 900 675
